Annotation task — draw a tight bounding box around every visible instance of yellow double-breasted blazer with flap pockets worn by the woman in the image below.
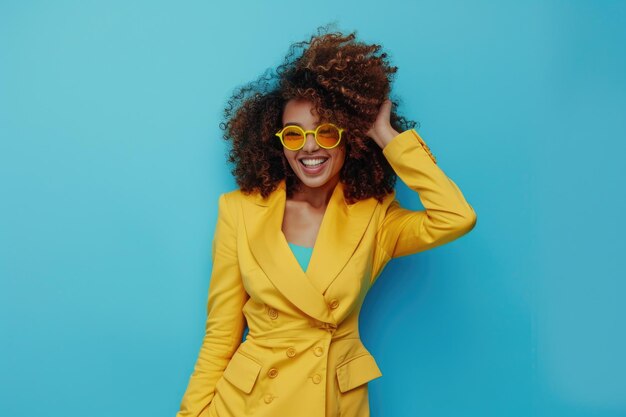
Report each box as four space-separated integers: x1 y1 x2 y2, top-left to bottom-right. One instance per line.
177 129 476 417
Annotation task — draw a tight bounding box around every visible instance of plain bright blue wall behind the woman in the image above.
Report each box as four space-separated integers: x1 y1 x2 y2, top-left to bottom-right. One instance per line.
0 0 626 417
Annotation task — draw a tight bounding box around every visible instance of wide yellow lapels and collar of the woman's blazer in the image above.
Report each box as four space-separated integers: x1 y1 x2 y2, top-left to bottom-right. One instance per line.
243 179 377 325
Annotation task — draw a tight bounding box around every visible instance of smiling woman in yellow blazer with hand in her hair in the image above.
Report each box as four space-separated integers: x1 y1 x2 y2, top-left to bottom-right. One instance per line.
173 26 476 417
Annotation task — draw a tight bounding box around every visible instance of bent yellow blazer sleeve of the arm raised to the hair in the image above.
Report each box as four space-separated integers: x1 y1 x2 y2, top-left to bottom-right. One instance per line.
376 129 476 280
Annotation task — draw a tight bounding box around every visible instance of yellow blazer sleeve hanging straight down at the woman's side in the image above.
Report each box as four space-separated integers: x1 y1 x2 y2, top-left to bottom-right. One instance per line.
176 194 249 417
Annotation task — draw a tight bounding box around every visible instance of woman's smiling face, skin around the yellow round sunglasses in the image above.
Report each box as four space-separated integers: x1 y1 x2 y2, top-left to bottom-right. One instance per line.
283 99 345 188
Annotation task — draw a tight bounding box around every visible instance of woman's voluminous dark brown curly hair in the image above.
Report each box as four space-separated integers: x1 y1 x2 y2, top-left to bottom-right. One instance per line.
220 26 416 203
